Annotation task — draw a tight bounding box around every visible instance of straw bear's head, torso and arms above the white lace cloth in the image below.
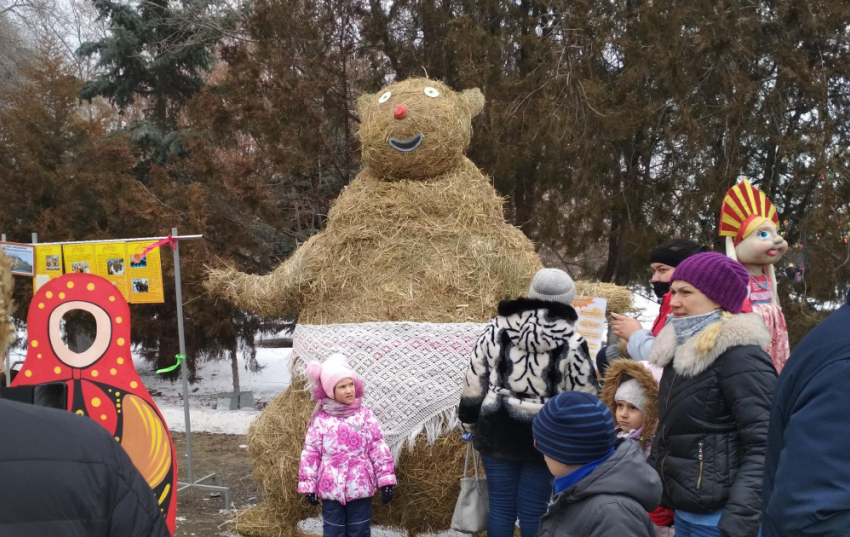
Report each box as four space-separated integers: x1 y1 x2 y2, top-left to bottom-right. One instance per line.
206 78 540 324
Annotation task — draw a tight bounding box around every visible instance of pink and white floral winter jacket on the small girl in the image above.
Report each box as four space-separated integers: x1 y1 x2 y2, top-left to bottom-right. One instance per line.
298 406 396 505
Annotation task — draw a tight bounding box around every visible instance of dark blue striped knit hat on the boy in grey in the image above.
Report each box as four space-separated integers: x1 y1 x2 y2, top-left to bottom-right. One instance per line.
532 392 615 464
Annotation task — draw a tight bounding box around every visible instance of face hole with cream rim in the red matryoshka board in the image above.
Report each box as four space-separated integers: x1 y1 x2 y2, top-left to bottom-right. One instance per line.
48 300 112 368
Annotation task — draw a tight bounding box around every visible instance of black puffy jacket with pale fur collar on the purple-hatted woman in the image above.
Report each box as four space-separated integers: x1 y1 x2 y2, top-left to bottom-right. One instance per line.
649 313 776 537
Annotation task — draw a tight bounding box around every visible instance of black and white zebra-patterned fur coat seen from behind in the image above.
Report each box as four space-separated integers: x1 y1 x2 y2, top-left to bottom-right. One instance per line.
458 298 599 460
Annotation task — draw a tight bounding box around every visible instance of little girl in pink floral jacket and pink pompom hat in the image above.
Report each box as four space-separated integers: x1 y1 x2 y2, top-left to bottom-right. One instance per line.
298 354 396 537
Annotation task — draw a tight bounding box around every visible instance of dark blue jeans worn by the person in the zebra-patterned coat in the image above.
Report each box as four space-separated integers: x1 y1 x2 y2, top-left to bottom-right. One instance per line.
481 455 552 537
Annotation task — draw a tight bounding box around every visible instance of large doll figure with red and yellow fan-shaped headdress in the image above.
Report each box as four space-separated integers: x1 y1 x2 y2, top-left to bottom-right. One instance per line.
720 179 790 373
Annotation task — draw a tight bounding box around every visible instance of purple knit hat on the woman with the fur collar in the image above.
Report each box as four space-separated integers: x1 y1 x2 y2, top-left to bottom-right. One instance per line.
670 252 750 313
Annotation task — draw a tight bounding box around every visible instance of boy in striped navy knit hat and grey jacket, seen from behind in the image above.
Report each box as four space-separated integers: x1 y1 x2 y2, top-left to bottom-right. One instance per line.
532 392 661 537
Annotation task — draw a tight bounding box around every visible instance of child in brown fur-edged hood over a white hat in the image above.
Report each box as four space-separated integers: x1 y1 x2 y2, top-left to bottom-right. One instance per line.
602 359 674 537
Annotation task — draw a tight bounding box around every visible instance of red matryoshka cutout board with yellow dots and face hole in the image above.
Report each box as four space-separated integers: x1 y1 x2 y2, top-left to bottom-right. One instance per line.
12 274 177 535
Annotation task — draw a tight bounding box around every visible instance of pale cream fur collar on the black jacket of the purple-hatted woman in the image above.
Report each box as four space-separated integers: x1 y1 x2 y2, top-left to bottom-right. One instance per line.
649 313 771 378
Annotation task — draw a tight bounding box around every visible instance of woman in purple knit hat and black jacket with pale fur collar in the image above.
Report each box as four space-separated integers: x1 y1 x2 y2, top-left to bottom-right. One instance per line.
649 252 776 537
